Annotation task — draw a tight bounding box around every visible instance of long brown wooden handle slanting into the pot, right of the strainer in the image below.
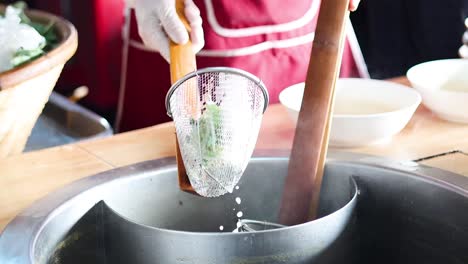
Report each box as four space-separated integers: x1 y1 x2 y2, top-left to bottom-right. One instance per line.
280 0 349 225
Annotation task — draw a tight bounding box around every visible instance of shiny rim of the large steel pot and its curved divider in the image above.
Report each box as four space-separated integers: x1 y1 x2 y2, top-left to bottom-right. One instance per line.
0 150 468 263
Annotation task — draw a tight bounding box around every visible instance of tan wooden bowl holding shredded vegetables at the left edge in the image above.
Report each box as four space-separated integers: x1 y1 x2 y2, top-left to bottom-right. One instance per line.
0 5 78 158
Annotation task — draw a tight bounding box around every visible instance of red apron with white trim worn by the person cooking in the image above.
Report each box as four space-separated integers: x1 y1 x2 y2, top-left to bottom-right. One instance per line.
120 0 365 131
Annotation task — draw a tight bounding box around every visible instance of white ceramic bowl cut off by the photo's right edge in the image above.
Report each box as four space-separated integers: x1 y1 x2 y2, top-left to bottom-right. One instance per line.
406 59 468 123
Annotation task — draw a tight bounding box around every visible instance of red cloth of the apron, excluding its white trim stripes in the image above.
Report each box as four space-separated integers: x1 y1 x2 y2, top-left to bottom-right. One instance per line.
121 0 358 131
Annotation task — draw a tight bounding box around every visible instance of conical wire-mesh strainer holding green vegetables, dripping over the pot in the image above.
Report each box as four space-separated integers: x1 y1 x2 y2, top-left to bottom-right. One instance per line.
166 67 268 197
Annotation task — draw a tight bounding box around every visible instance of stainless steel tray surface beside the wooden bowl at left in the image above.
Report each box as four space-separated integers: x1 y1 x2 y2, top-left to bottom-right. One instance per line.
25 92 113 152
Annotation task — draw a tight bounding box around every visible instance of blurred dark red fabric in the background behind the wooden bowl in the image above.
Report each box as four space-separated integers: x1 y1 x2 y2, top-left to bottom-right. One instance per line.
34 0 124 115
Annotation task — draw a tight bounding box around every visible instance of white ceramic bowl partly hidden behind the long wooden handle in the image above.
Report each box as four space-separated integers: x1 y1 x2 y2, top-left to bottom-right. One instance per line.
279 78 421 147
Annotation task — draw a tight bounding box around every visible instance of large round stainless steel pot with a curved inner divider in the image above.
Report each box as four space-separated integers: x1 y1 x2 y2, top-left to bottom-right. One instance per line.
0 153 468 264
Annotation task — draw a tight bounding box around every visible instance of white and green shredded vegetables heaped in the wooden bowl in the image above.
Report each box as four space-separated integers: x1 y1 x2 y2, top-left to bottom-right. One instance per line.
0 2 57 72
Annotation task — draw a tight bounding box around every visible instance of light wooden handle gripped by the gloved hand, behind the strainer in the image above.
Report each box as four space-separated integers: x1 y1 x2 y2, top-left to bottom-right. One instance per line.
169 0 197 193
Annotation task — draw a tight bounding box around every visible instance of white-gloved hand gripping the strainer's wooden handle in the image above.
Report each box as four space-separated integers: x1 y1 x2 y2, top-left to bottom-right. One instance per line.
132 0 205 62
